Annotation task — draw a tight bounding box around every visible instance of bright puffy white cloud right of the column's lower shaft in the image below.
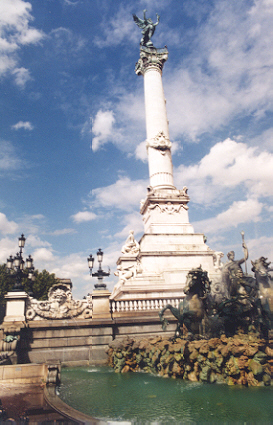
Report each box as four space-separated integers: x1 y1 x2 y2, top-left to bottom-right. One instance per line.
175 139 273 205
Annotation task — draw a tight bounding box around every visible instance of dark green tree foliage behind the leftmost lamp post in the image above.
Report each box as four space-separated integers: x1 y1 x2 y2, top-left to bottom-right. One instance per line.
0 264 58 303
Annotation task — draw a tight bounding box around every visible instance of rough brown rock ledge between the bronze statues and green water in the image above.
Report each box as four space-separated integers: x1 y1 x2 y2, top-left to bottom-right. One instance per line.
105 335 273 386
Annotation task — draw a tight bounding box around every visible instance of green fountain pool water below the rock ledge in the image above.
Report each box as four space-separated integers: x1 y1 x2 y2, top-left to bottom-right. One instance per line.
59 367 273 425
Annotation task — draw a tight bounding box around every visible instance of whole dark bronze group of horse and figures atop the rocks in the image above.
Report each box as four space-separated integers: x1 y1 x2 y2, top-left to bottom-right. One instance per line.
159 232 273 338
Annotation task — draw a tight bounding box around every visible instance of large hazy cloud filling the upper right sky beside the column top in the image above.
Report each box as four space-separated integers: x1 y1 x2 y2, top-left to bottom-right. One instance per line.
164 0 273 140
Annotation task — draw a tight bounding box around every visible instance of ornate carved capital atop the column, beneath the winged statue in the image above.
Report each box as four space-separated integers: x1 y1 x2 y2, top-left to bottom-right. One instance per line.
135 46 169 75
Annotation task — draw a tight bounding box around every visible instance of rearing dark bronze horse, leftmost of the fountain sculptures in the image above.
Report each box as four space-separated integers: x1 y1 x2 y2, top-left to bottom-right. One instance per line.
159 266 210 337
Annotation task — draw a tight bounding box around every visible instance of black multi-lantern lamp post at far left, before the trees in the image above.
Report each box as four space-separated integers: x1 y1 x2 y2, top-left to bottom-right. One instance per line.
7 234 34 295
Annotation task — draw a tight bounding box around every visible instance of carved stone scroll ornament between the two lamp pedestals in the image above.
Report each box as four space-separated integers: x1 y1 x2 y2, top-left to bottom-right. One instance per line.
26 281 92 320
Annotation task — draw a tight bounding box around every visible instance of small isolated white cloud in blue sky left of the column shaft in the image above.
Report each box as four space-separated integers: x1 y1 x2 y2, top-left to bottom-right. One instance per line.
92 110 115 152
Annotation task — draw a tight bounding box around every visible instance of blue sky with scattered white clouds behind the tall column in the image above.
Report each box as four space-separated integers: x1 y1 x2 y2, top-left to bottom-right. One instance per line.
0 0 273 297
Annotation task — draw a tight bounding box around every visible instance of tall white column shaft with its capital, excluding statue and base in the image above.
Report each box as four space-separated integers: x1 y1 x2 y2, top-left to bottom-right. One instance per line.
136 46 174 189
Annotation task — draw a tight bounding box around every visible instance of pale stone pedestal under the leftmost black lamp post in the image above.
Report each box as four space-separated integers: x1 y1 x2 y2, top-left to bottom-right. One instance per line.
4 291 28 322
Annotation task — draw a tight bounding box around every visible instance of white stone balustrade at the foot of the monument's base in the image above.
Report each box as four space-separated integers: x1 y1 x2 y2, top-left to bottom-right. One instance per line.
110 298 182 313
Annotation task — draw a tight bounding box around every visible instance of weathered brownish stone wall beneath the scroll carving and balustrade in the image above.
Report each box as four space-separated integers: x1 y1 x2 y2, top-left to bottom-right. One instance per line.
14 312 175 366
